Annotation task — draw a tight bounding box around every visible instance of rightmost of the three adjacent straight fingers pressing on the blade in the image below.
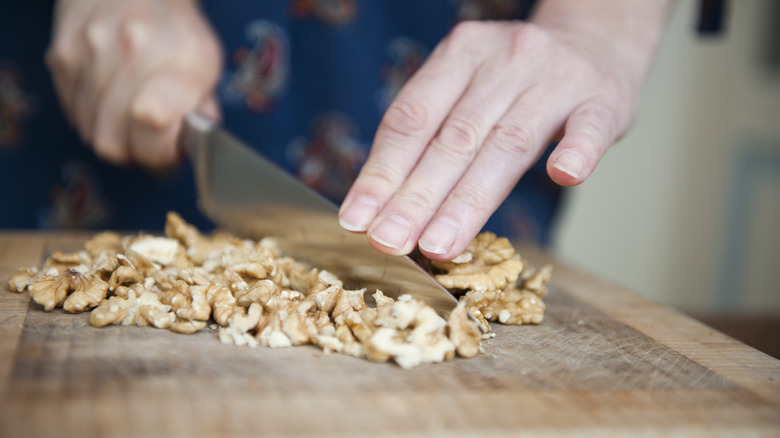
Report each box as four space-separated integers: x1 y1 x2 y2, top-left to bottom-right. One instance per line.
419 86 572 260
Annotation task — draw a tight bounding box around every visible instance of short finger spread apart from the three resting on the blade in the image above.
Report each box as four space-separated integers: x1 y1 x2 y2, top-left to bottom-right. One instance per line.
547 101 618 186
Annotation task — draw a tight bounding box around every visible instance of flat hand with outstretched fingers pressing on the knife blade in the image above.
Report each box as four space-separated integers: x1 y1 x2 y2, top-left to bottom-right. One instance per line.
339 2 672 260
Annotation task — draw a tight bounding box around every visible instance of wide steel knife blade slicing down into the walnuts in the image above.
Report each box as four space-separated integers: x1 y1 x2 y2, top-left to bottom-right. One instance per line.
178 112 457 318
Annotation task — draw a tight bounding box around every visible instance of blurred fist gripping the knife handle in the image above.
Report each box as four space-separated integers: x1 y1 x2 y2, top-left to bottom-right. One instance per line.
46 0 222 168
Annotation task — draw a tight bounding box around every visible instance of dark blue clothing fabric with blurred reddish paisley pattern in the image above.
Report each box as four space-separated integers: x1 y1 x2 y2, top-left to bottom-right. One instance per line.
0 0 562 244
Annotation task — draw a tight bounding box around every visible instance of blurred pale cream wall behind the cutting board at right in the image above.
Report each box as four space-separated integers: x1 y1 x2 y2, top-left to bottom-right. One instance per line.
556 0 780 313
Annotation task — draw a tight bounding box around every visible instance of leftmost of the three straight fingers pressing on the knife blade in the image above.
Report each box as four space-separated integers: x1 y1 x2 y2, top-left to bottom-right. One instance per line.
339 39 475 232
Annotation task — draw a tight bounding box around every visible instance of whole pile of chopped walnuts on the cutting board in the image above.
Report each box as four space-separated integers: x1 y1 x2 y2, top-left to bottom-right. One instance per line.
9 213 551 368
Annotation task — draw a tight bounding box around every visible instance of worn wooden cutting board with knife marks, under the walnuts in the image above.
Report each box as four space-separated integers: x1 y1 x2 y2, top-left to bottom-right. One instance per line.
0 232 780 437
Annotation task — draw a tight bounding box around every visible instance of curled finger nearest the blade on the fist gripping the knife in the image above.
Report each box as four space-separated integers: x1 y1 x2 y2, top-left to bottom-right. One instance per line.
128 71 215 168
